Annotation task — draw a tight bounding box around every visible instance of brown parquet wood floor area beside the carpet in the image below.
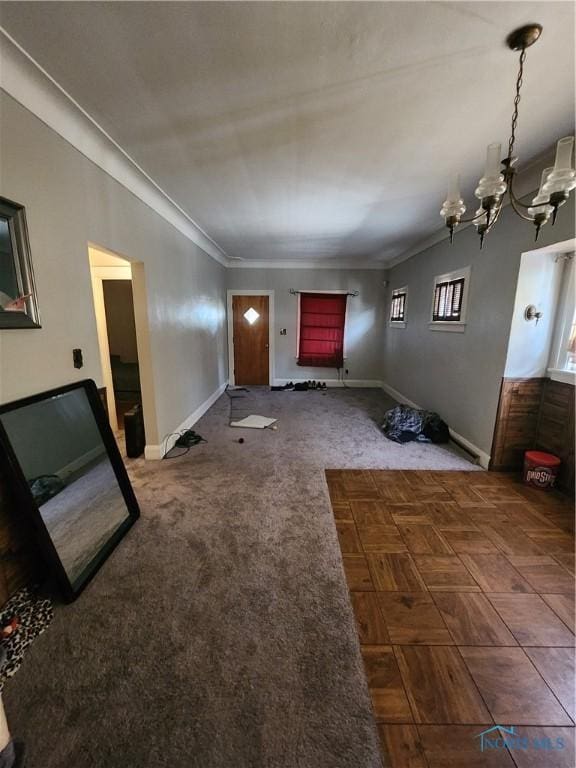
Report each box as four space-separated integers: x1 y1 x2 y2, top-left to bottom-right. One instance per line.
326 470 576 768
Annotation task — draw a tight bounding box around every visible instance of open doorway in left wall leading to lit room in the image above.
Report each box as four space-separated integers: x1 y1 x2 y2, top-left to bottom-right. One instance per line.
88 245 157 452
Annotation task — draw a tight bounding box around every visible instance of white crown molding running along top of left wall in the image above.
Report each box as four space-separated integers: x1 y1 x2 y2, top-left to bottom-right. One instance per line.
0 26 230 266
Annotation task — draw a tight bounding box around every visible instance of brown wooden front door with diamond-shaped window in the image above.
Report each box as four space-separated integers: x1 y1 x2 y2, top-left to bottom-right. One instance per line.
232 296 270 385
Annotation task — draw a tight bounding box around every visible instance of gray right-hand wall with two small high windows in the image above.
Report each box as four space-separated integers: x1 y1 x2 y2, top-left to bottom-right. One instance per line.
382 204 574 453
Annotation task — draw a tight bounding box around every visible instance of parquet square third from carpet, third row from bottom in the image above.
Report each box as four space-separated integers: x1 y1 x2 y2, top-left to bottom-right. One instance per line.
434 592 518 645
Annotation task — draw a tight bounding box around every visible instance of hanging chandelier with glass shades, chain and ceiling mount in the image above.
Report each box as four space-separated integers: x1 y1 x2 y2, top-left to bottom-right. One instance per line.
440 24 576 248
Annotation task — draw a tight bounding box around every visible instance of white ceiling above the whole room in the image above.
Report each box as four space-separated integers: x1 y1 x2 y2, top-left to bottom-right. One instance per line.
0 2 575 263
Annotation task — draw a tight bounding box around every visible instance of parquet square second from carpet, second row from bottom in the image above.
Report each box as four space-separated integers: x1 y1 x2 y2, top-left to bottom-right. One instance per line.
394 645 491 724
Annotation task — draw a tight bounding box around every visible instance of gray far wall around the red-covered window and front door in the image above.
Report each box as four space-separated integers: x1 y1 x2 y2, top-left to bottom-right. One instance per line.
228 269 385 381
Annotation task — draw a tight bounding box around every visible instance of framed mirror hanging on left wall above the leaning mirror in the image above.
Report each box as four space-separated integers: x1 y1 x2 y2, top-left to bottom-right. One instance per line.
0 197 40 330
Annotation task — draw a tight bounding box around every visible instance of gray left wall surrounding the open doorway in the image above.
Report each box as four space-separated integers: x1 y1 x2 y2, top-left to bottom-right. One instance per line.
0 92 227 443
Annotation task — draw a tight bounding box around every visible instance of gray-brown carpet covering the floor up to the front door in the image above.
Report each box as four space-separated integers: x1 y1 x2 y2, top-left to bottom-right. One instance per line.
4 390 480 768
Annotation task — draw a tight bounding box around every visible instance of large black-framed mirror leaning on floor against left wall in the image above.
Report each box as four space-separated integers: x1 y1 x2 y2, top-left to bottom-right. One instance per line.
0 380 140 600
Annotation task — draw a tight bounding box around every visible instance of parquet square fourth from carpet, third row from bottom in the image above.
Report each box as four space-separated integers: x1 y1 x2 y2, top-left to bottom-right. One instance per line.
488 594 574 647
